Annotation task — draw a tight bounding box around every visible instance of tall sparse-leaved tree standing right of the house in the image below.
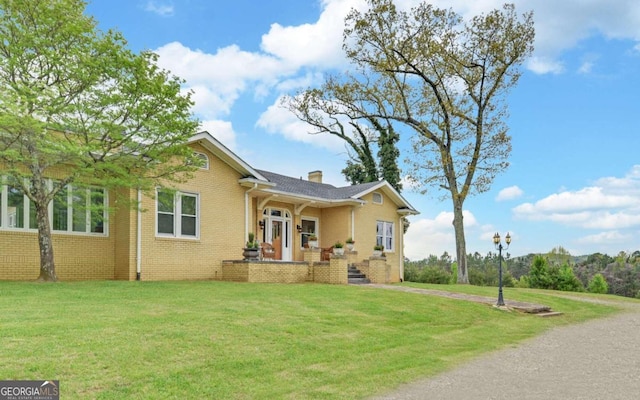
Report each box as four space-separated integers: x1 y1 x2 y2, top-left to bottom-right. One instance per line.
288 0 534 283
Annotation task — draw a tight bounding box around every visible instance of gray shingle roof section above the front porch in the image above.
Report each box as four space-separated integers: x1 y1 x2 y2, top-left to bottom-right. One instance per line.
256 170 380 200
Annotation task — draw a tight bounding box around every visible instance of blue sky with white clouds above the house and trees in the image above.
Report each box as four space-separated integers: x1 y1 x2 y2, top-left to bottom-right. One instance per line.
87 0 640 259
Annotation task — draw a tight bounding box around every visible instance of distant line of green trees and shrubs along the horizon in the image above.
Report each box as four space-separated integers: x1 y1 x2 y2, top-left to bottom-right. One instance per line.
405 247 640 298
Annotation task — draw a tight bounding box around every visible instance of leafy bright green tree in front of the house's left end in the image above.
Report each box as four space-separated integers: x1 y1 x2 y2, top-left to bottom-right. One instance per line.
0 0 198 281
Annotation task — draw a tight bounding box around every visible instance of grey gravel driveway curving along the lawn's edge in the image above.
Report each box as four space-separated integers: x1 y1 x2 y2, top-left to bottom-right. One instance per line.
372 306 640 400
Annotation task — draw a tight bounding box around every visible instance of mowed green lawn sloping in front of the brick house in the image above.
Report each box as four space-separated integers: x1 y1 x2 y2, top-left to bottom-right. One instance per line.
0 282 617 399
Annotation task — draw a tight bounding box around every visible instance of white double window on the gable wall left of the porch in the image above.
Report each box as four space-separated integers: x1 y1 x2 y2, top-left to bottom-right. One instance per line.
156 190 199 238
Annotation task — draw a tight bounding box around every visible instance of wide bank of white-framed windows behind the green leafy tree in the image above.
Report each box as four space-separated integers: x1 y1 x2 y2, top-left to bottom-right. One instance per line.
0 178 107 234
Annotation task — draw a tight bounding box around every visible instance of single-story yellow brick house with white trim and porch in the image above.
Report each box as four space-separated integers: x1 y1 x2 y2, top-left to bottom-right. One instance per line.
0 132 417 282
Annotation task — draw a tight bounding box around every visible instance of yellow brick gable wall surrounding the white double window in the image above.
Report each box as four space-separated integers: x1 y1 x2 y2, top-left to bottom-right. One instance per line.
136 147 246 280
